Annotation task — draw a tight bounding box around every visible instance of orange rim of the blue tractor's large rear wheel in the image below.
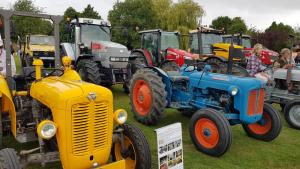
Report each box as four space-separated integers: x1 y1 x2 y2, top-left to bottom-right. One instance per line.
133 80 152 116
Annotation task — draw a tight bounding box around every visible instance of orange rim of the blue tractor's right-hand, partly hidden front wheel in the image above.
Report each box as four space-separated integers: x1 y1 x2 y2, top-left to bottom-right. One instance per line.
248 113 272 135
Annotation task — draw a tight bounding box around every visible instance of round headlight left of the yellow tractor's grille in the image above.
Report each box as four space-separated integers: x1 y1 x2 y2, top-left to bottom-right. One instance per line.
37 120 57 140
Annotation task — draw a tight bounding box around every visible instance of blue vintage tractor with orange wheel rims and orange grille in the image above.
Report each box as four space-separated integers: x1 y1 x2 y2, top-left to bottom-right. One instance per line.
130 65 282 156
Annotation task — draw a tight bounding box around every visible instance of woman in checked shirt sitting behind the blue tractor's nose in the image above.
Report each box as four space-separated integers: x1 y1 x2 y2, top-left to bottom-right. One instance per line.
247 43 270 83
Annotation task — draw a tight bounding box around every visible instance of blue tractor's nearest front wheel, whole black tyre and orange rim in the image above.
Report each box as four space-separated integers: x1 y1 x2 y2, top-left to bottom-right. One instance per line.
189 109 232 157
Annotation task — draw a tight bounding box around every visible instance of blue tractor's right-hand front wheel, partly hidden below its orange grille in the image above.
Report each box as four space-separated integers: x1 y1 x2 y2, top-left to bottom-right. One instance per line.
243 103 282 141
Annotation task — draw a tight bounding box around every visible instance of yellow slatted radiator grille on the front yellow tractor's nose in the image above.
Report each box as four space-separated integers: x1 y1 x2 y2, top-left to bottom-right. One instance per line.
72 102 108 155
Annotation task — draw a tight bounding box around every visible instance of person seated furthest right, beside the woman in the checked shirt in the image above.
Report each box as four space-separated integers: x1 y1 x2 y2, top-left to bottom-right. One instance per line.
274 48 295 69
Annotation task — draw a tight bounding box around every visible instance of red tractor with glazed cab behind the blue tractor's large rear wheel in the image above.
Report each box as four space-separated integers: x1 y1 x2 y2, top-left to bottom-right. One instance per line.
129 29 195 73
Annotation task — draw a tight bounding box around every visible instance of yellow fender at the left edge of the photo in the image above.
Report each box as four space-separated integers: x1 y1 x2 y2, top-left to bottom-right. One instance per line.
0 75 17 137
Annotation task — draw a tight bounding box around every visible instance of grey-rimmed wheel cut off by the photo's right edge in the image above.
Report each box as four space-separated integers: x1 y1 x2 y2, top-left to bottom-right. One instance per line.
284 100 300 130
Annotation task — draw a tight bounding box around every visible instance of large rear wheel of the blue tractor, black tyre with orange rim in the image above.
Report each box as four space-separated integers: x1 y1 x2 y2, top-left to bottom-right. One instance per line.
129 69 167 125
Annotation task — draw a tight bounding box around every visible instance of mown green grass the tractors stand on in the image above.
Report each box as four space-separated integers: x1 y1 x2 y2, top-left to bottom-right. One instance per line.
6 86 300 169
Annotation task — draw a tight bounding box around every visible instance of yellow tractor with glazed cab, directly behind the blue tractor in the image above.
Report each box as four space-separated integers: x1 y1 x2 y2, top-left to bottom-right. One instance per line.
189 26 248 76
